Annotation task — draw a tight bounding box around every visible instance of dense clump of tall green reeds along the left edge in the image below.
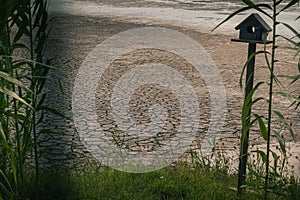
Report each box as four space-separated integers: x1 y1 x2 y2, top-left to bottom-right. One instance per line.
0 0 52 199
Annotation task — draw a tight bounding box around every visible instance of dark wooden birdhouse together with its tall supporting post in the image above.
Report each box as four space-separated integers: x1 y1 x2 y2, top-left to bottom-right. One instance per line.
231 13 272 195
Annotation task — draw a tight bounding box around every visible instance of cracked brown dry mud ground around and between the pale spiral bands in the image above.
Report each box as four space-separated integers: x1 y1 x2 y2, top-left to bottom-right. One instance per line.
40 13 300 171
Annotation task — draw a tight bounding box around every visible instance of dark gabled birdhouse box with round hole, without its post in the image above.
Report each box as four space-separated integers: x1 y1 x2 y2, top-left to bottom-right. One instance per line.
235 13 272 43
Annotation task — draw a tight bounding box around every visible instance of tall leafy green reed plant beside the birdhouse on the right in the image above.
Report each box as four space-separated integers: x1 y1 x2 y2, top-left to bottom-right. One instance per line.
216 0 300 199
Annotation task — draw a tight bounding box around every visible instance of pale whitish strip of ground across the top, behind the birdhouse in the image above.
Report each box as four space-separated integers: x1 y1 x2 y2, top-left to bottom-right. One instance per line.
49 0 300 36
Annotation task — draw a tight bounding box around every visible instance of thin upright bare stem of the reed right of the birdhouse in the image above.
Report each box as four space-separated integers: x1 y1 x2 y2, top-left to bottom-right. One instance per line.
264 0 276 200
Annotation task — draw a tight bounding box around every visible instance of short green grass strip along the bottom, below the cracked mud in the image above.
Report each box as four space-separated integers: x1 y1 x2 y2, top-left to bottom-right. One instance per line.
22 163 299 200
